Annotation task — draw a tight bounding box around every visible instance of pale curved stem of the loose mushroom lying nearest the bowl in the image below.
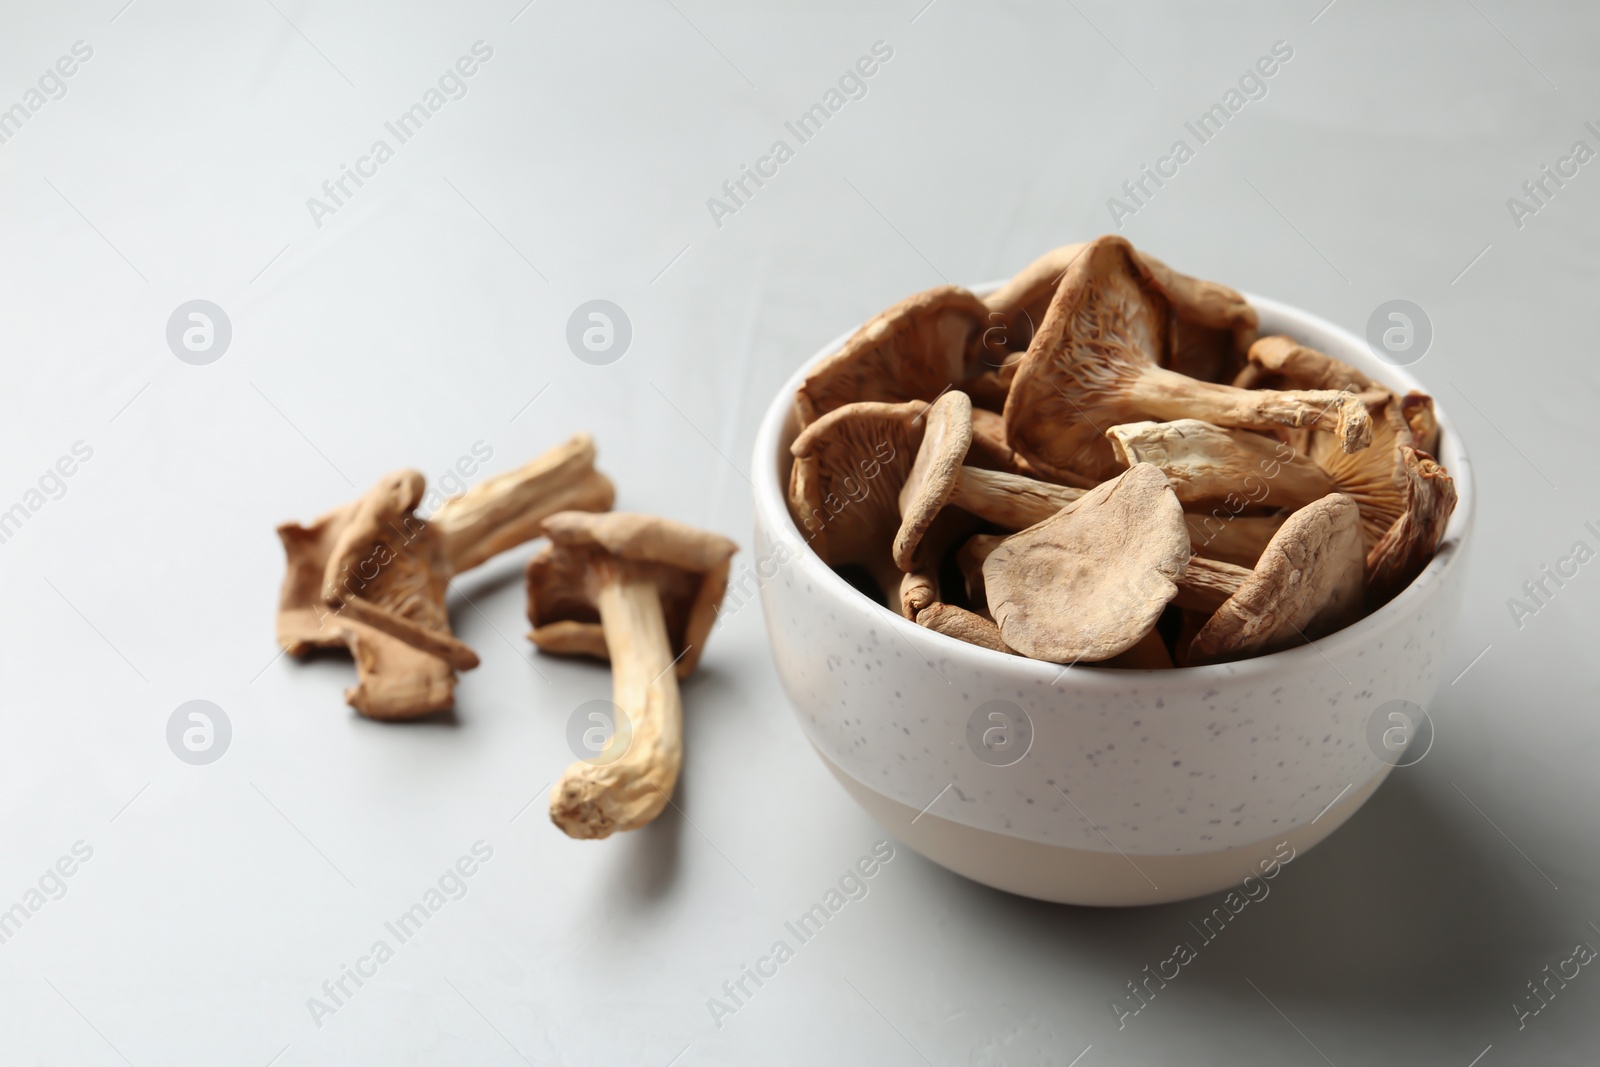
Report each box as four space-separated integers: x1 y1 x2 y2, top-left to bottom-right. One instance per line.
550 560 683 838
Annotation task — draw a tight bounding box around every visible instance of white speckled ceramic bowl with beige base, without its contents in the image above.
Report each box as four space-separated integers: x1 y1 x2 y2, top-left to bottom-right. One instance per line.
754 286 1474 905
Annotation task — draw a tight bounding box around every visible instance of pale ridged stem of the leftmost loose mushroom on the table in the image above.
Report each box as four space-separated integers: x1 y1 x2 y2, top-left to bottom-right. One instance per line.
429 434 616 573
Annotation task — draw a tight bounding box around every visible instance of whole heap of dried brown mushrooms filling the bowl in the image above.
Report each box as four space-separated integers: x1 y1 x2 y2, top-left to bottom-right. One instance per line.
789 237 1456 669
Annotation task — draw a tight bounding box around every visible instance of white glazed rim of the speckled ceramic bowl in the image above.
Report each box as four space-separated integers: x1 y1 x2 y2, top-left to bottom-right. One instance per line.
752 282 1477 688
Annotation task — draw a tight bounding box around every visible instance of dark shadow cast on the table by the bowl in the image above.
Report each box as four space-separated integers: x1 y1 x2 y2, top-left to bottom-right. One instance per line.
908 773 1582 1021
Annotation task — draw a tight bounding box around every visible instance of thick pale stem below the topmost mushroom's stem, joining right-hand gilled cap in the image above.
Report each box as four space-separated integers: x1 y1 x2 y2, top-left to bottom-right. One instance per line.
1106 419 1337 507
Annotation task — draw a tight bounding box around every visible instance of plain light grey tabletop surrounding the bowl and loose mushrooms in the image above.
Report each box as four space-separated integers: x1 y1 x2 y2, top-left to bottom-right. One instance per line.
0 0 1600 1067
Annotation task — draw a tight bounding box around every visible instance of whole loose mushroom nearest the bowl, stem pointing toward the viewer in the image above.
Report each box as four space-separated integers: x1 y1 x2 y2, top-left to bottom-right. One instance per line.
528 512 738 838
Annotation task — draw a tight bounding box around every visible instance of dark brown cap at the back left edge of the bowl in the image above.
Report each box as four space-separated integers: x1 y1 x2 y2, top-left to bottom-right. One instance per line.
795 292 989 427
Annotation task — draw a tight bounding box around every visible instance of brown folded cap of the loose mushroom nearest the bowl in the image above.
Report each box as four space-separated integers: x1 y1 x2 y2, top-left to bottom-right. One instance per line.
526 512 739 678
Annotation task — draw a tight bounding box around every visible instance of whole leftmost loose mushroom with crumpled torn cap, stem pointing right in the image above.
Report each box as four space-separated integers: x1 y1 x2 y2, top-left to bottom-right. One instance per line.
277 434 613 720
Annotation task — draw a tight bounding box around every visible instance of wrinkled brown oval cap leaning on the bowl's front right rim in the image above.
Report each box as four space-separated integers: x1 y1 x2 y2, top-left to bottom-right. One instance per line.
1189 493 1365 665
